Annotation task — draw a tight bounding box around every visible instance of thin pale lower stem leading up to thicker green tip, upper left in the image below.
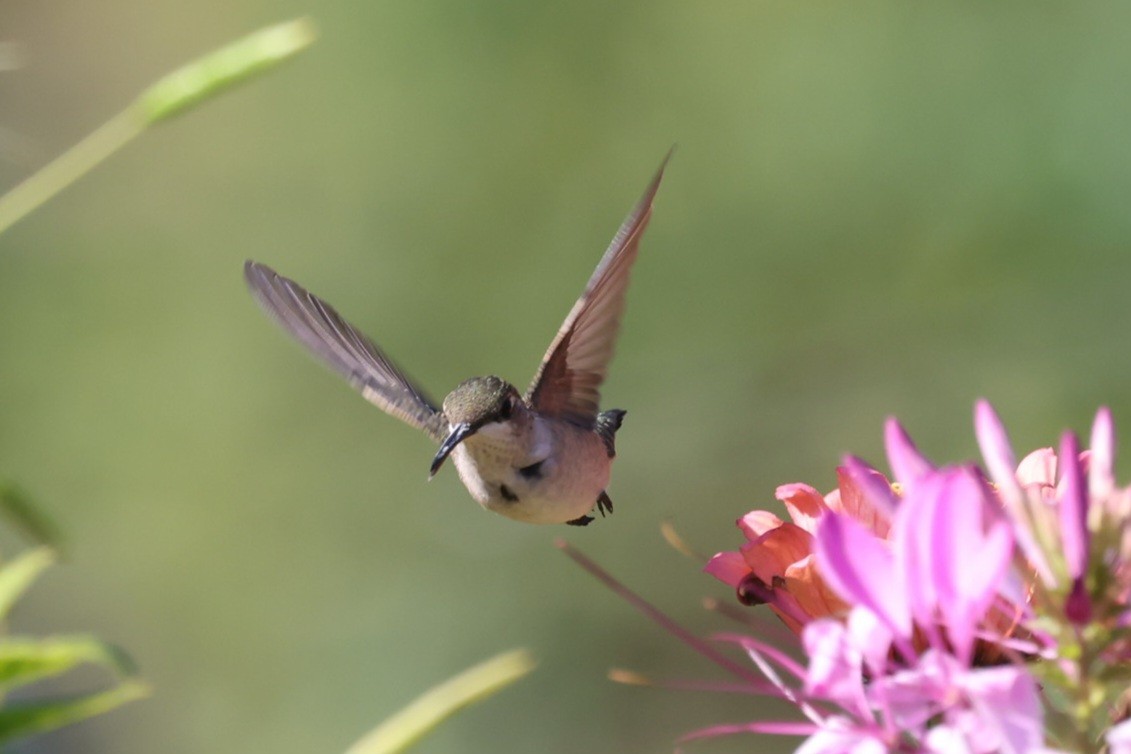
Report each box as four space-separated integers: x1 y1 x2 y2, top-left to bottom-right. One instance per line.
0 106 145 233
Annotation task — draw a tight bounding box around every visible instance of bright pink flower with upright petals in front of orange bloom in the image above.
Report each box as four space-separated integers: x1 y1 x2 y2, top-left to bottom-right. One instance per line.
803 422 1044 754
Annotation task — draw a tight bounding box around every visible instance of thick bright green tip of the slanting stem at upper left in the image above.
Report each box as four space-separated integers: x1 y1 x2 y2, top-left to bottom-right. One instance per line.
136 18 314 123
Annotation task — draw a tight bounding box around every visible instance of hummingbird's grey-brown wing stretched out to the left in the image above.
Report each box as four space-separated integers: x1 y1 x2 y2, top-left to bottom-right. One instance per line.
243 260 447 442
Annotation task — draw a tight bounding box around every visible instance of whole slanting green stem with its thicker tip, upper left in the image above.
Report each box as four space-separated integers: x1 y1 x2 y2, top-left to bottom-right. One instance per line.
0 18 314 233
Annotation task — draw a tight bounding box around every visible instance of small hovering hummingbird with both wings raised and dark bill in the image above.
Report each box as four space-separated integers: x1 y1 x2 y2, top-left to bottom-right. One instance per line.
243 153 671 526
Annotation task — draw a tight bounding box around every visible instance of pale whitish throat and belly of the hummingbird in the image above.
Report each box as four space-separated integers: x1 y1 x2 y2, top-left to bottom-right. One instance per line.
451 418 612 523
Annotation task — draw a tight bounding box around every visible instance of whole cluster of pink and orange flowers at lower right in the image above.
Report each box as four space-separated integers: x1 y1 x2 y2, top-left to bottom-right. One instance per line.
705 401 1131 754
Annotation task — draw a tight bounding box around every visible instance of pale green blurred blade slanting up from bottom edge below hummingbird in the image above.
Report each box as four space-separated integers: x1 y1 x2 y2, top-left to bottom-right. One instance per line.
346 649 535 754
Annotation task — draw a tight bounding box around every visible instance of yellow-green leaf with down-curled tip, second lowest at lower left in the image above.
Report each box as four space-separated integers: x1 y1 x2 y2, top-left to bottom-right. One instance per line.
0 635 136 692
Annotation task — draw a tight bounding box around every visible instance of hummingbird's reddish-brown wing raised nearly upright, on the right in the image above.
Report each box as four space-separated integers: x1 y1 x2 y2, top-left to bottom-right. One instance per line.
526 151 672 426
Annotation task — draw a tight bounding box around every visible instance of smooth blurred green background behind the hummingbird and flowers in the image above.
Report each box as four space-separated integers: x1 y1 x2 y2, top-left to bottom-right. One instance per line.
0 0 1131 754
